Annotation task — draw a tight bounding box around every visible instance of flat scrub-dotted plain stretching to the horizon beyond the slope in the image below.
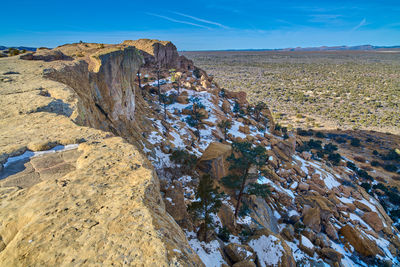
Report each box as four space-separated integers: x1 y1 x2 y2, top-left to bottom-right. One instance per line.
184 51 400 133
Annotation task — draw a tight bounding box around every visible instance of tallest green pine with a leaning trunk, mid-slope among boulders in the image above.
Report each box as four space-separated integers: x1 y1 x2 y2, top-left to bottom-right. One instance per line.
222 142 268 218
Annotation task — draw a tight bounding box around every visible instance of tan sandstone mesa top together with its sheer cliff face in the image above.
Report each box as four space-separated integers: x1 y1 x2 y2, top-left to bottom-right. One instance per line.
0 41 203 266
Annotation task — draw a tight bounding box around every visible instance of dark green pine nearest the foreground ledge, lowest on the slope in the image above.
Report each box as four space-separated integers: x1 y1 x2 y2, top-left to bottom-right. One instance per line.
188 174 223 242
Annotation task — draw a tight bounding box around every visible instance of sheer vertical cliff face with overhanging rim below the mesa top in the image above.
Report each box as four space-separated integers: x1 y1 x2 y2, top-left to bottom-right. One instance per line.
44 46 142 137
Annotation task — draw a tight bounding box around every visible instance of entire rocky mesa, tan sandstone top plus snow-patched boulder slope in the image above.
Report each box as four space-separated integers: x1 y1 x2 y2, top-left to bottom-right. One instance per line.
0 39 400 267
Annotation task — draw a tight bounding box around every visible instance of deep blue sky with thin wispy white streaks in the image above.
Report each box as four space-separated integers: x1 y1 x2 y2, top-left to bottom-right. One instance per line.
0 0 400 50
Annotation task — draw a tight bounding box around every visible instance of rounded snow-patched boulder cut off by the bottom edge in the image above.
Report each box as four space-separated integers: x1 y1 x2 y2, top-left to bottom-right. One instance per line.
248 229 296 267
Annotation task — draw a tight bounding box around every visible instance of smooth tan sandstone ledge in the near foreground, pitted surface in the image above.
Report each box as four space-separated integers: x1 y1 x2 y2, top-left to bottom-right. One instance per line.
0 138 201 266
